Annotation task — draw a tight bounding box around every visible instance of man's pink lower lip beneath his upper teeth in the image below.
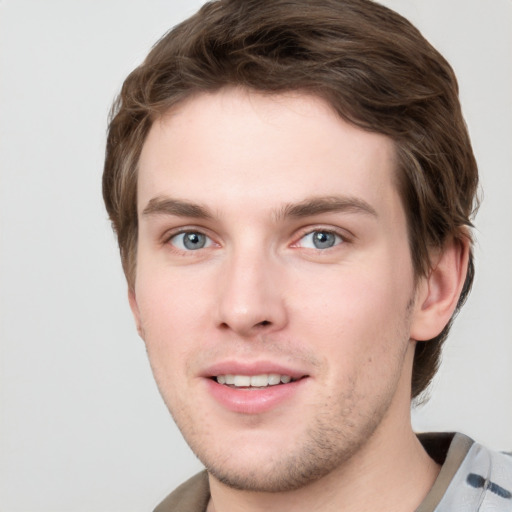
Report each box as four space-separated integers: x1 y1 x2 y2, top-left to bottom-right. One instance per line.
207 378 307 414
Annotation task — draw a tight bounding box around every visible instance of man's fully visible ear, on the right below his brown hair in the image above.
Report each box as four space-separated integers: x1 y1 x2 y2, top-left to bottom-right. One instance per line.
410 237 469 341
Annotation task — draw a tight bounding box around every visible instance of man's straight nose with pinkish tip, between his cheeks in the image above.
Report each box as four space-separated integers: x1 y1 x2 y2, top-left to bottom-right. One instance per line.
217 247 287 338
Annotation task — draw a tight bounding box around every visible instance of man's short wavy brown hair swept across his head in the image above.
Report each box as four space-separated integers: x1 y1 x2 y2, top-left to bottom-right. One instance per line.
103 0 478 397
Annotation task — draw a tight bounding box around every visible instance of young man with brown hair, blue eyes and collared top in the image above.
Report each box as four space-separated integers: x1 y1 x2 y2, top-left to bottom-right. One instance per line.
103 0 512 512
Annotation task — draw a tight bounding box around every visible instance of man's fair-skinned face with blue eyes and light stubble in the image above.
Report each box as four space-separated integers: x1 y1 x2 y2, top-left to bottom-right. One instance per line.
130 89 416 491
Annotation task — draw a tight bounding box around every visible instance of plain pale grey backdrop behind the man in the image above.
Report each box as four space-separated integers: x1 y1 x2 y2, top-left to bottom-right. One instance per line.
0 0 512 512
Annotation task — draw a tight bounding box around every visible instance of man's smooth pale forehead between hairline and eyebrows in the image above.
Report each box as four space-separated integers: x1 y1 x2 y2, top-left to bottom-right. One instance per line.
138 89 396 216
